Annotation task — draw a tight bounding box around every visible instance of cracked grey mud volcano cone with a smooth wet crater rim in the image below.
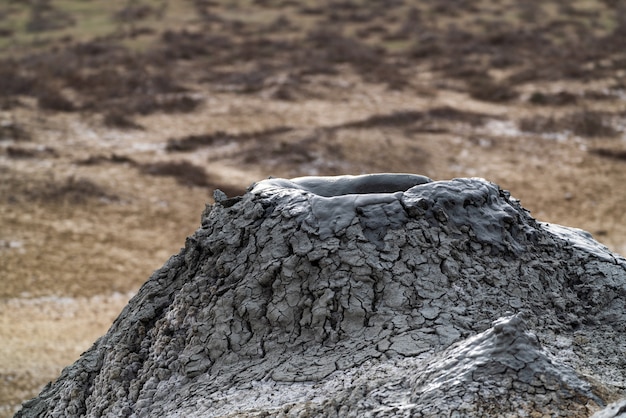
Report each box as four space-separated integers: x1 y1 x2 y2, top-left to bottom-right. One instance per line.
17 174 626 417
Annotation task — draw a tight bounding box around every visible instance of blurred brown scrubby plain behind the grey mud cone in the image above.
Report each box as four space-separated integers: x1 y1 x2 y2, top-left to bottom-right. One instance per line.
0 0 626 417
